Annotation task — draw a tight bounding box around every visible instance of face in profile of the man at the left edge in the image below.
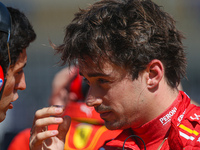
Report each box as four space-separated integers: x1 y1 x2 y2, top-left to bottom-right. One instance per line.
0 49 27 122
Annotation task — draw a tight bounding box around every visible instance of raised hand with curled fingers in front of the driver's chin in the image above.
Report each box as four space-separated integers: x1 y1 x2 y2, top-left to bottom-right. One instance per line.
29 106 71 150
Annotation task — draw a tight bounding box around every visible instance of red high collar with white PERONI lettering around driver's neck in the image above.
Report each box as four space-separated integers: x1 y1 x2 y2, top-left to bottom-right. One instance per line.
106 91 190 150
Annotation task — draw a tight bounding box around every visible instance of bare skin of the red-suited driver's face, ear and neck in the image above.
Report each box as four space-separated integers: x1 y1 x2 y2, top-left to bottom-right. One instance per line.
79 60 178 130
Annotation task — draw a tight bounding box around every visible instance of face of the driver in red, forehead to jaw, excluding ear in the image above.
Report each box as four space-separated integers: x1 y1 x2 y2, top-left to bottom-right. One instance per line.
79 61 147 130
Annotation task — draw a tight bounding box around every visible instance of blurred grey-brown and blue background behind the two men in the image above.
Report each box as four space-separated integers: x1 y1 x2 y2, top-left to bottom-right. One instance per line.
0 0 200 150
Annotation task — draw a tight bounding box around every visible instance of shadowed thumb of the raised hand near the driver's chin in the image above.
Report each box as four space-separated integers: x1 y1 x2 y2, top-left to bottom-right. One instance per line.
57 116 71 142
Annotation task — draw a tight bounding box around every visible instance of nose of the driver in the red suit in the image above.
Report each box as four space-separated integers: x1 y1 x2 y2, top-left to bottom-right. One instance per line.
86 87 103 107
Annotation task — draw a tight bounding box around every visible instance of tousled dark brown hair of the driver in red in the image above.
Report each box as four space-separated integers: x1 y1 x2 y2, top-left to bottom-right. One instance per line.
55 0 186 88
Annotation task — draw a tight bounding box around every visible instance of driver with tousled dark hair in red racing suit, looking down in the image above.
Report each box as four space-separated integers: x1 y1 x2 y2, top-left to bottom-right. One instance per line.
31 0 200 150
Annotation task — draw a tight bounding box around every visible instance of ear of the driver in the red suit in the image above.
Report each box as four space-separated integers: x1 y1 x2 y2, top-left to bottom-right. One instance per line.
146 59 164 89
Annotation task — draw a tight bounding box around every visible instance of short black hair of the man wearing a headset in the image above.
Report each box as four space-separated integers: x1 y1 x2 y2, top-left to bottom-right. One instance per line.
0 7 36 73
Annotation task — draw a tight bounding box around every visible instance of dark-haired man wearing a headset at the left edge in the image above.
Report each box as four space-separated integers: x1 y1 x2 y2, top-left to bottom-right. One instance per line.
0 3 36 122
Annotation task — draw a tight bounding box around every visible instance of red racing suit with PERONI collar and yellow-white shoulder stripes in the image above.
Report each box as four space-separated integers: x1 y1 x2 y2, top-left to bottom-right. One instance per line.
101 91 200 150
